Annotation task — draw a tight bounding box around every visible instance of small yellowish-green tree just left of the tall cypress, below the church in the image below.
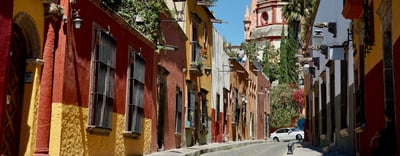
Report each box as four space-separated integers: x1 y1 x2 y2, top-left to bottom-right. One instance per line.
263 41 279 82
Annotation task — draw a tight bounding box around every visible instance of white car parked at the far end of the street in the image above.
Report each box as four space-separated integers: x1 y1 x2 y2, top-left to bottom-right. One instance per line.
271 128 304 142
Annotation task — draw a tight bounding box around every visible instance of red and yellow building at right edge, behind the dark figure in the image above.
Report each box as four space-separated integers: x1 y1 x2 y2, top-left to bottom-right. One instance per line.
342 0 399 155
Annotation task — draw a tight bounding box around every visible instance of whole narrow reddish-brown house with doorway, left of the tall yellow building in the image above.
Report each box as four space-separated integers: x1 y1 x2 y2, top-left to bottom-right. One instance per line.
152 15 187 150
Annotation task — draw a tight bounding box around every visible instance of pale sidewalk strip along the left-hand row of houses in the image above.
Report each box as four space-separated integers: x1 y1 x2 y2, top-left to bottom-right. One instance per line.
146 140 267 156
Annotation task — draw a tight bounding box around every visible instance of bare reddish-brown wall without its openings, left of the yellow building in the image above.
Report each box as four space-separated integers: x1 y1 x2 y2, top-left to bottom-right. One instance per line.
156 15 187 150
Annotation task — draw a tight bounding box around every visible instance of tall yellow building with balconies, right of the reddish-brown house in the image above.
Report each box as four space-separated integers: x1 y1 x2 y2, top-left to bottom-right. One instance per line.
182 0 219 146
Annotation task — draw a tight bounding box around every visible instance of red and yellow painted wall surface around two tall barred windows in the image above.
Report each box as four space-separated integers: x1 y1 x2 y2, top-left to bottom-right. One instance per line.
50 0 156 155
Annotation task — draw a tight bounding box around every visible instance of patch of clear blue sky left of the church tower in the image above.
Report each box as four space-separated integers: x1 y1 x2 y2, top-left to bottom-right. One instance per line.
210 0 251 45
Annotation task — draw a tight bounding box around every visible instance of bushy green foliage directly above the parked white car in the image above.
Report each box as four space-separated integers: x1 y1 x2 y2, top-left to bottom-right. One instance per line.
270 84 302 128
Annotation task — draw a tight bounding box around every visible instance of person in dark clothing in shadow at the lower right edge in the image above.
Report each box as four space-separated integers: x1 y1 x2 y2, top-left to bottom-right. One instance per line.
370 109 397 156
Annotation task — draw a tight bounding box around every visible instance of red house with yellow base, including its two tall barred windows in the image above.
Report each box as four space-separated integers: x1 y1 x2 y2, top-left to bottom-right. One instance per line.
39 0 157 155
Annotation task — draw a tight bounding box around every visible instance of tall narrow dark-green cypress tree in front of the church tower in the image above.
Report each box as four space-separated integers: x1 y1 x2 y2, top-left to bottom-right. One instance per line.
279 27 299 84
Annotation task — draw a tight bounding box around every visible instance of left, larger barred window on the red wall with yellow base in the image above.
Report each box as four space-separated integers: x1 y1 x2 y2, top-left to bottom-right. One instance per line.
88 30 116 135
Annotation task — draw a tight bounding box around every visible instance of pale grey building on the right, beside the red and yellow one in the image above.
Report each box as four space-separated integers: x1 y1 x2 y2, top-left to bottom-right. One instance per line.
305 0 354 155
